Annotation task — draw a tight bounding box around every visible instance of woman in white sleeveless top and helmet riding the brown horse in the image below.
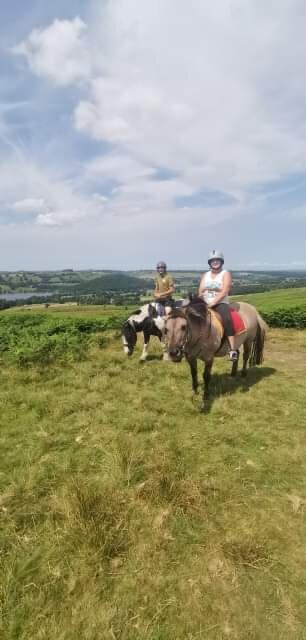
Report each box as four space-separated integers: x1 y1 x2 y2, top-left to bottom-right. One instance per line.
198 249 238 361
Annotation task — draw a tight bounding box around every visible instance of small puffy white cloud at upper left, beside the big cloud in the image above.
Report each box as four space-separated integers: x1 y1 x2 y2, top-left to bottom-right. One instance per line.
13 17 91 86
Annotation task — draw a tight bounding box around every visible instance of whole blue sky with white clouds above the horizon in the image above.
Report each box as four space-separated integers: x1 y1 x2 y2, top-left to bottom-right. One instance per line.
0 0 306 270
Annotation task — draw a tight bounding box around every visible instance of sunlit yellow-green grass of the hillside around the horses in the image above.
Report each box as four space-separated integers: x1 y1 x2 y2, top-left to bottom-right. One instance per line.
0 308 306 640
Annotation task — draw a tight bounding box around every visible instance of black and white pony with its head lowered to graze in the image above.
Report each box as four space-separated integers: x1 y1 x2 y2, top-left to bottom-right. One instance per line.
121 302 169 362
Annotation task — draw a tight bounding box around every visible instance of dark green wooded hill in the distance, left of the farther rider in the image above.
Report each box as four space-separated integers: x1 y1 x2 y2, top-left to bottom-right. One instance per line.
75 272 152 293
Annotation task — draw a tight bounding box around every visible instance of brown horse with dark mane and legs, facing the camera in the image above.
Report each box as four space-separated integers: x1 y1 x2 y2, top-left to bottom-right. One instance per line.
165 298 267 400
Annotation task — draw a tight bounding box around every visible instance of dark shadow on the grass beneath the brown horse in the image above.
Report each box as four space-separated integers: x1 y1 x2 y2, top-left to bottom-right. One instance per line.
201 367 276 413
